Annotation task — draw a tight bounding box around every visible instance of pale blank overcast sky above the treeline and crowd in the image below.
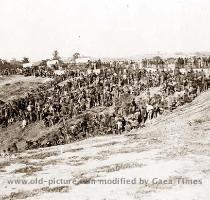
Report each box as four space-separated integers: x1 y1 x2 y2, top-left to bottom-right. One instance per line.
0 0 210 60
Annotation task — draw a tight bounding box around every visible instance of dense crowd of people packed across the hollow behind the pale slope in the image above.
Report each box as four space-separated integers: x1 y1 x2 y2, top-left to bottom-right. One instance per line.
0 62 209 152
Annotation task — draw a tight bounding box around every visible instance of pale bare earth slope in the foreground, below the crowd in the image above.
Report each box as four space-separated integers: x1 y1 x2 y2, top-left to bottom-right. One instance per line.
0 91 210 200
